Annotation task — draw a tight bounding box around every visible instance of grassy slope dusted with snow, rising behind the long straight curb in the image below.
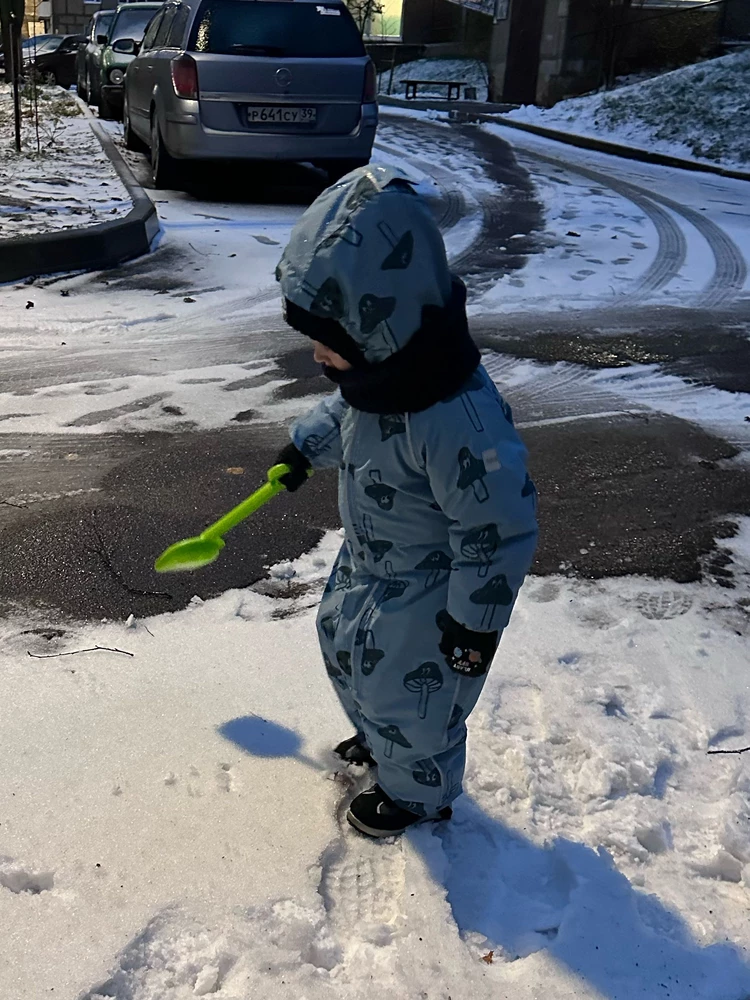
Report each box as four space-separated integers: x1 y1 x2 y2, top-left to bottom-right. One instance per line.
507 49 750 170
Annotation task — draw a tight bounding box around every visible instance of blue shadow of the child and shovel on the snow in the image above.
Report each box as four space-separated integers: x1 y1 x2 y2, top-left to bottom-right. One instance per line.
219 716 750 1000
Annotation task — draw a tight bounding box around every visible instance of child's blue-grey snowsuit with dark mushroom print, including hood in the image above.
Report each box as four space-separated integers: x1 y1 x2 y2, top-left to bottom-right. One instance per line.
278 167 537 815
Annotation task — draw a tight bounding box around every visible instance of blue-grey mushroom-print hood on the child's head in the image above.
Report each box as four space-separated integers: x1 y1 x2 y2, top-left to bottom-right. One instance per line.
276 165 452 365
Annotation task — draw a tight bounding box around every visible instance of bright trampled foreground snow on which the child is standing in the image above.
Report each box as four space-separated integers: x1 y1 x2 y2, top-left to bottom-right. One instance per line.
0 524 750 1000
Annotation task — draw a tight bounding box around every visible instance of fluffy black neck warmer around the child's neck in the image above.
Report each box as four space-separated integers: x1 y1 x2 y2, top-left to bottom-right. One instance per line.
317 279 481 413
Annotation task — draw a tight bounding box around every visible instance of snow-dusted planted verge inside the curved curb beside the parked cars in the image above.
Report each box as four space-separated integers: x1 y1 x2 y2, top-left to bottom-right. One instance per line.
0 86 132 239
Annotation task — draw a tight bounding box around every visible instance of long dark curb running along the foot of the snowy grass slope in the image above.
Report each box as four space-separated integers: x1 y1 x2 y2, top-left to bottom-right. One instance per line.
380 97 750 181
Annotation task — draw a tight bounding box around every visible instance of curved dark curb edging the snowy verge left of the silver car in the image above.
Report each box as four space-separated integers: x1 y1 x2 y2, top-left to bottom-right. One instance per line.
0 108 159 282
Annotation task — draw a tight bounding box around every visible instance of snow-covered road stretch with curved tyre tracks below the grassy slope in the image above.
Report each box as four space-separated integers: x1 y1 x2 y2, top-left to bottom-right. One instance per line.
474 125 750 312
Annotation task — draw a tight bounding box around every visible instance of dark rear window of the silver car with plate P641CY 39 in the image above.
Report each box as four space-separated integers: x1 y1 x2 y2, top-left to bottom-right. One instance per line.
190 0 365 59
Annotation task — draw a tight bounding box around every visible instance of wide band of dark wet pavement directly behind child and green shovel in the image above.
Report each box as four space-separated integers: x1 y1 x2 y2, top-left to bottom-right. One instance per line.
0 350 750 618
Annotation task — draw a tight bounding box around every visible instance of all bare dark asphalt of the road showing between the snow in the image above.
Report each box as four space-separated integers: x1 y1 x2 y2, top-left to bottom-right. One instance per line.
0 124 750 621
